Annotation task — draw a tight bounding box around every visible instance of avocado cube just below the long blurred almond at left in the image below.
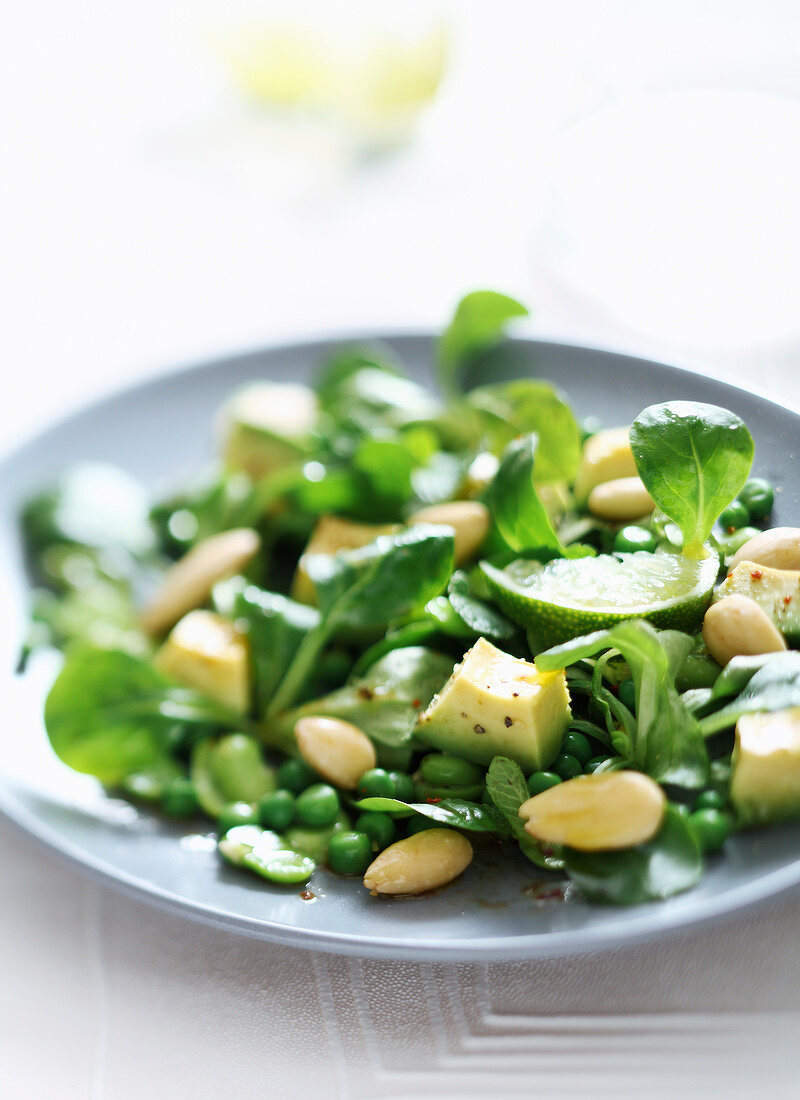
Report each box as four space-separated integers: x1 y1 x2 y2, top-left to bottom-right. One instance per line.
155 611 250 714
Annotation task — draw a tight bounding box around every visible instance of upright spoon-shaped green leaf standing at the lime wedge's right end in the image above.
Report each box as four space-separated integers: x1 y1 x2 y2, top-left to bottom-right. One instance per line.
631 402 754 557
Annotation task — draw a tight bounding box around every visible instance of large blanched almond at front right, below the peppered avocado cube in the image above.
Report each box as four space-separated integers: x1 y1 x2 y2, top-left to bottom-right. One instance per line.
519 771 667 851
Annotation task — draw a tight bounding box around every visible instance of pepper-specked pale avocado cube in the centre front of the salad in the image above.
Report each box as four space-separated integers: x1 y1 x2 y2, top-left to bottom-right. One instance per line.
414 638 570 771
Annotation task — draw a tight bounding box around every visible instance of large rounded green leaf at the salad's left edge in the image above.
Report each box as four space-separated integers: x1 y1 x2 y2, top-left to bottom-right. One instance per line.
44 649 238 785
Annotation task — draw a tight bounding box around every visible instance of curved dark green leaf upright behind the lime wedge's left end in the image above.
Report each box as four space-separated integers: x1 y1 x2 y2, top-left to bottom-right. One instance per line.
486 436 562 554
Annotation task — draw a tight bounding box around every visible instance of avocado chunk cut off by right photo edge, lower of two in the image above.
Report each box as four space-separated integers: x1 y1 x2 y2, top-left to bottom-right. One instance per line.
731 706 800 825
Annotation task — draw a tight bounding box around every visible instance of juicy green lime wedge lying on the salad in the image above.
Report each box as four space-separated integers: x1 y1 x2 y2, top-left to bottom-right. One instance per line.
481 551 720 648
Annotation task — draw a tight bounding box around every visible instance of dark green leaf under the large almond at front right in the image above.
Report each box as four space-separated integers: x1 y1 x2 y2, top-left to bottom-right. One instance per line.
563 806 703 905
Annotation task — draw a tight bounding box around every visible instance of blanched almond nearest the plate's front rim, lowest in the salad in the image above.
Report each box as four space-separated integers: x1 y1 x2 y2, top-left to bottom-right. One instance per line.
364 828 472 894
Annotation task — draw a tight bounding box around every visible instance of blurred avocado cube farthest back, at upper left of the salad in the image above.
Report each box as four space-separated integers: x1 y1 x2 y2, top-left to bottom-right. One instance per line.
221 382 317 479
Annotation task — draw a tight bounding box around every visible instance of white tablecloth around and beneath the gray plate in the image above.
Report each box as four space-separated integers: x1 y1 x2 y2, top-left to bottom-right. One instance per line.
0 0 800 1100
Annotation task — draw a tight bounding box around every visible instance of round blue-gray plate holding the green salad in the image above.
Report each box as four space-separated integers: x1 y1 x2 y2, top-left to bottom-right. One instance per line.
0 336 800 960
